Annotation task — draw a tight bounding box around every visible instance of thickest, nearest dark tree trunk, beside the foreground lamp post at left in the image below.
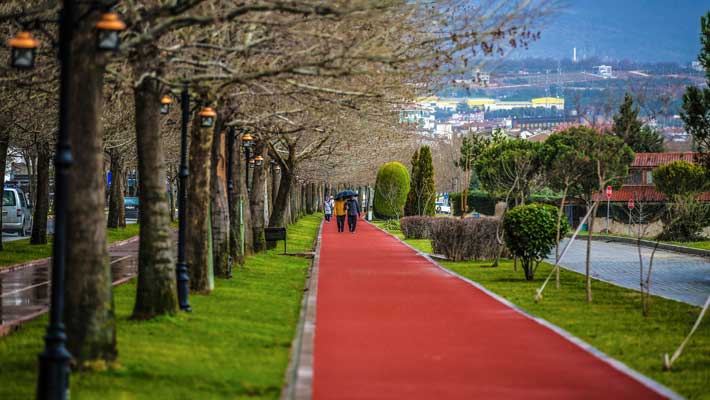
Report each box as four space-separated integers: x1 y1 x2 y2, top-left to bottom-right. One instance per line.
64 8 118 368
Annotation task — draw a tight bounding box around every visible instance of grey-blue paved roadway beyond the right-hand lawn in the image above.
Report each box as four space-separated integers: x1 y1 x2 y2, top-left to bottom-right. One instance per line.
548 239 710 306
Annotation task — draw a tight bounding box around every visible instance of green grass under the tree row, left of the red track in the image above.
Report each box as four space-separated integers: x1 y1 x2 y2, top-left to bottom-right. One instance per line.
0 215 321 400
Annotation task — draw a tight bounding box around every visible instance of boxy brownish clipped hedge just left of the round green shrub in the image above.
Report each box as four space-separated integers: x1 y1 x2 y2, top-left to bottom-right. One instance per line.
429 217 507 261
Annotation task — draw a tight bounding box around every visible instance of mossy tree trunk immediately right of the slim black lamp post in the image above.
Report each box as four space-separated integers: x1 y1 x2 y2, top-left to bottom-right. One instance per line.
185 112 213 293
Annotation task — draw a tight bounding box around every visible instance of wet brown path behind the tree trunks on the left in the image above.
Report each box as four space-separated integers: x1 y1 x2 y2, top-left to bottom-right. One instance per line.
0 238 138 336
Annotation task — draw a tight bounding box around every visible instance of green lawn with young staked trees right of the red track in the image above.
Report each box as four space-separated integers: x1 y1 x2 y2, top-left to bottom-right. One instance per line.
378 223 710 399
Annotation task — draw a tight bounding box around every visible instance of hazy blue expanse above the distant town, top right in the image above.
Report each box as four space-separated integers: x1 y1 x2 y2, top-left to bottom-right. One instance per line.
516 0 710 64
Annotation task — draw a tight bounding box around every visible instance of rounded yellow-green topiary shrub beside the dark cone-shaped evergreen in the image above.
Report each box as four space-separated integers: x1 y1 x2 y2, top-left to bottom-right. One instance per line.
374 161 410 219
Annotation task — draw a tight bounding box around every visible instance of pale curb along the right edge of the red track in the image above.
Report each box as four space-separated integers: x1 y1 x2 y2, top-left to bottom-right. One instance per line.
371 220 683 400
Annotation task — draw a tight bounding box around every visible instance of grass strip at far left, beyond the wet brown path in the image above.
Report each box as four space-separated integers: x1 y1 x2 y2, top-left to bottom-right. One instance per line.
0 224 140 268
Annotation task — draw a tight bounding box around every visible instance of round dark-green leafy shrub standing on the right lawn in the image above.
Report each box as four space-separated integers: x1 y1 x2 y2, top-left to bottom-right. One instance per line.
503 203 569 281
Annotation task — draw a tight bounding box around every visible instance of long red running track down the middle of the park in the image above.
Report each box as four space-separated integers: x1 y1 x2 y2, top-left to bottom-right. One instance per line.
313 221 662 400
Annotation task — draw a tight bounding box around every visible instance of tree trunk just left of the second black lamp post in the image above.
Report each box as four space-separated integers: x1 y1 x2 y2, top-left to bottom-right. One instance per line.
132 69 178 319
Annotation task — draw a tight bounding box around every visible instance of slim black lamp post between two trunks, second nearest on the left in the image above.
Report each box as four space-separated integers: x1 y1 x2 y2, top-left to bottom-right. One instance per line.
176 83 192 312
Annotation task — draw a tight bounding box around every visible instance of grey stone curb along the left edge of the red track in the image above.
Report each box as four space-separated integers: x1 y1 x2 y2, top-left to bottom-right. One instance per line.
279 221 323 400
